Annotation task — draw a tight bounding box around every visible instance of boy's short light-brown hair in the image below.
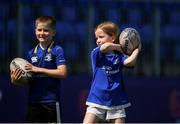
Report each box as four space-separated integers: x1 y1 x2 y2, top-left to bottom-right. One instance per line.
35 16 56 30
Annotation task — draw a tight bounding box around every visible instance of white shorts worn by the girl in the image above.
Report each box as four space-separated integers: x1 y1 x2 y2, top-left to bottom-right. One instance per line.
87 106 126 120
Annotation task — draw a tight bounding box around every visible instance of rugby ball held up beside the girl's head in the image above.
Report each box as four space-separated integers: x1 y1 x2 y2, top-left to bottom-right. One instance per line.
119 28 141 55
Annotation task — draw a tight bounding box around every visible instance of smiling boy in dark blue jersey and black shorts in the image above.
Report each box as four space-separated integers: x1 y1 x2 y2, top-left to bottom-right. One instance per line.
11 16 67 123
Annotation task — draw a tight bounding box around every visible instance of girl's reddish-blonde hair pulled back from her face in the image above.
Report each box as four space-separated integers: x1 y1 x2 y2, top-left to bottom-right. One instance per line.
95 22 119 44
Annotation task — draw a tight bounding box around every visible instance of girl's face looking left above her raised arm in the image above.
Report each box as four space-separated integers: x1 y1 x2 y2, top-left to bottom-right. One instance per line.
95 28 115 46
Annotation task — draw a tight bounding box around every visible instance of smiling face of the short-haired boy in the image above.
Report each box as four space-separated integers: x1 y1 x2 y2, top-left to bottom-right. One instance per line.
35 23 55 44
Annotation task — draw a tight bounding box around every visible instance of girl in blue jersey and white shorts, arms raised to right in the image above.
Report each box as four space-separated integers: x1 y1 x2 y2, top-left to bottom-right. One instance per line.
83 22 141 123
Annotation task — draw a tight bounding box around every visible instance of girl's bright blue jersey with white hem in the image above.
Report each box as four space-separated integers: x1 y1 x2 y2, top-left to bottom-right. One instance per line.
86 47 130 109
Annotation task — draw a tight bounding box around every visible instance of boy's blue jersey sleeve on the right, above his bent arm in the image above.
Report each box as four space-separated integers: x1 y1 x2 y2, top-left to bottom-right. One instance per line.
56 46 66 66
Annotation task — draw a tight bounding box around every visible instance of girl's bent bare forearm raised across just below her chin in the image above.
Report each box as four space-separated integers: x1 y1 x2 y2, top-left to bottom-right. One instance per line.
100 42 123 53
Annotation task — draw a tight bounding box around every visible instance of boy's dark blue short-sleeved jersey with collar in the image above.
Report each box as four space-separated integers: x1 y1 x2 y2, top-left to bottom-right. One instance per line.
27 44 66 103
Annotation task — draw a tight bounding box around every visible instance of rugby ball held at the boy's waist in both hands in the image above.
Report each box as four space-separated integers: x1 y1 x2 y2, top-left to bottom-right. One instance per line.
10 58 32 85
